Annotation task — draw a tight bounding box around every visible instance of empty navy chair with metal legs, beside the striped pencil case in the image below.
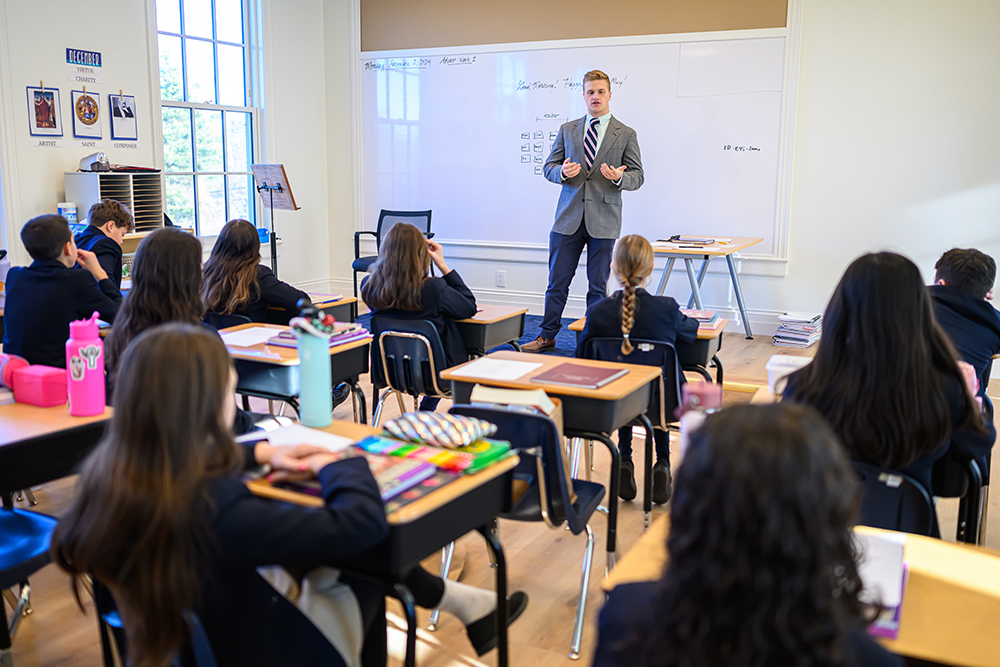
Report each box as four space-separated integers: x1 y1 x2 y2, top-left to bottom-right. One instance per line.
452 405 604 660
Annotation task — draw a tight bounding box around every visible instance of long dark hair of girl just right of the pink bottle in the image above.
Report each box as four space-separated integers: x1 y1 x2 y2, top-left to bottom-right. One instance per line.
104 227 205 381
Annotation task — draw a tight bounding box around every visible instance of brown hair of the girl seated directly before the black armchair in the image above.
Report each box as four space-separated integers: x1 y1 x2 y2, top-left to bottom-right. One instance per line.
361 222 431 310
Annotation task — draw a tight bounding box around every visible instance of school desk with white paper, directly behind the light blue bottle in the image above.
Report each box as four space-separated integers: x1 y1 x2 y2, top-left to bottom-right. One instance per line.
219 323 371 423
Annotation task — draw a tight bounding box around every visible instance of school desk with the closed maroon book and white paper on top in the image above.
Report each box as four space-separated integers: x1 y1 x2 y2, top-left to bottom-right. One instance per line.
441 351 663 568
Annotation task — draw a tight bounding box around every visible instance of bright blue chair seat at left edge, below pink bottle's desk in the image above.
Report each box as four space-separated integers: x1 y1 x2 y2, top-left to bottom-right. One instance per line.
0 507 56 667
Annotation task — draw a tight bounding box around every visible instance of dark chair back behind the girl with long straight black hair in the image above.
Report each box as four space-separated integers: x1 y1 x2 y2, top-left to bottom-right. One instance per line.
851 461 939 537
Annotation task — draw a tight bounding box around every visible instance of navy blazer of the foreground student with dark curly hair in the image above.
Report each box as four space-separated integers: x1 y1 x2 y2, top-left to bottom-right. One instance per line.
593 582 903 667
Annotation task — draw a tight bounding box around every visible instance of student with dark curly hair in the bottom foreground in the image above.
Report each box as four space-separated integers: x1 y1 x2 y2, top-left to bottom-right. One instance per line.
594 403 905 667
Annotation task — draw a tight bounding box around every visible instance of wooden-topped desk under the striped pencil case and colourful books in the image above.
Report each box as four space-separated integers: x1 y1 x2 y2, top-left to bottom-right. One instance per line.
247 421 518 666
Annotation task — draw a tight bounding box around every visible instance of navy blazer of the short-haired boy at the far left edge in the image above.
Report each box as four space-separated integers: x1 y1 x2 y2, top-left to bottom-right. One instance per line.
3 259 122 368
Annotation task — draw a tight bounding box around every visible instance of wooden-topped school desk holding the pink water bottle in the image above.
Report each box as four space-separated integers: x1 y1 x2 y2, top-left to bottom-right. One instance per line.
0 397 111 506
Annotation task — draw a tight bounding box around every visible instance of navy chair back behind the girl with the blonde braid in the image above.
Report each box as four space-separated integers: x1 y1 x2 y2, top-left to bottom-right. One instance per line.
583 337 684 429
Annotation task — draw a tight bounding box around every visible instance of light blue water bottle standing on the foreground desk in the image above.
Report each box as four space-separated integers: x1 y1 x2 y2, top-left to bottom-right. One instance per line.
289 302 333 428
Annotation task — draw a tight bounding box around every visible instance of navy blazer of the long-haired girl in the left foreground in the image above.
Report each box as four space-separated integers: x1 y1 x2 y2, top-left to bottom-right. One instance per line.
198 457 389 667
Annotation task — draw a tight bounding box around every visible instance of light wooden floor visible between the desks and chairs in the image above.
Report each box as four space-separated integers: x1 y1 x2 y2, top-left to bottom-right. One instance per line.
7 333 1000 667
